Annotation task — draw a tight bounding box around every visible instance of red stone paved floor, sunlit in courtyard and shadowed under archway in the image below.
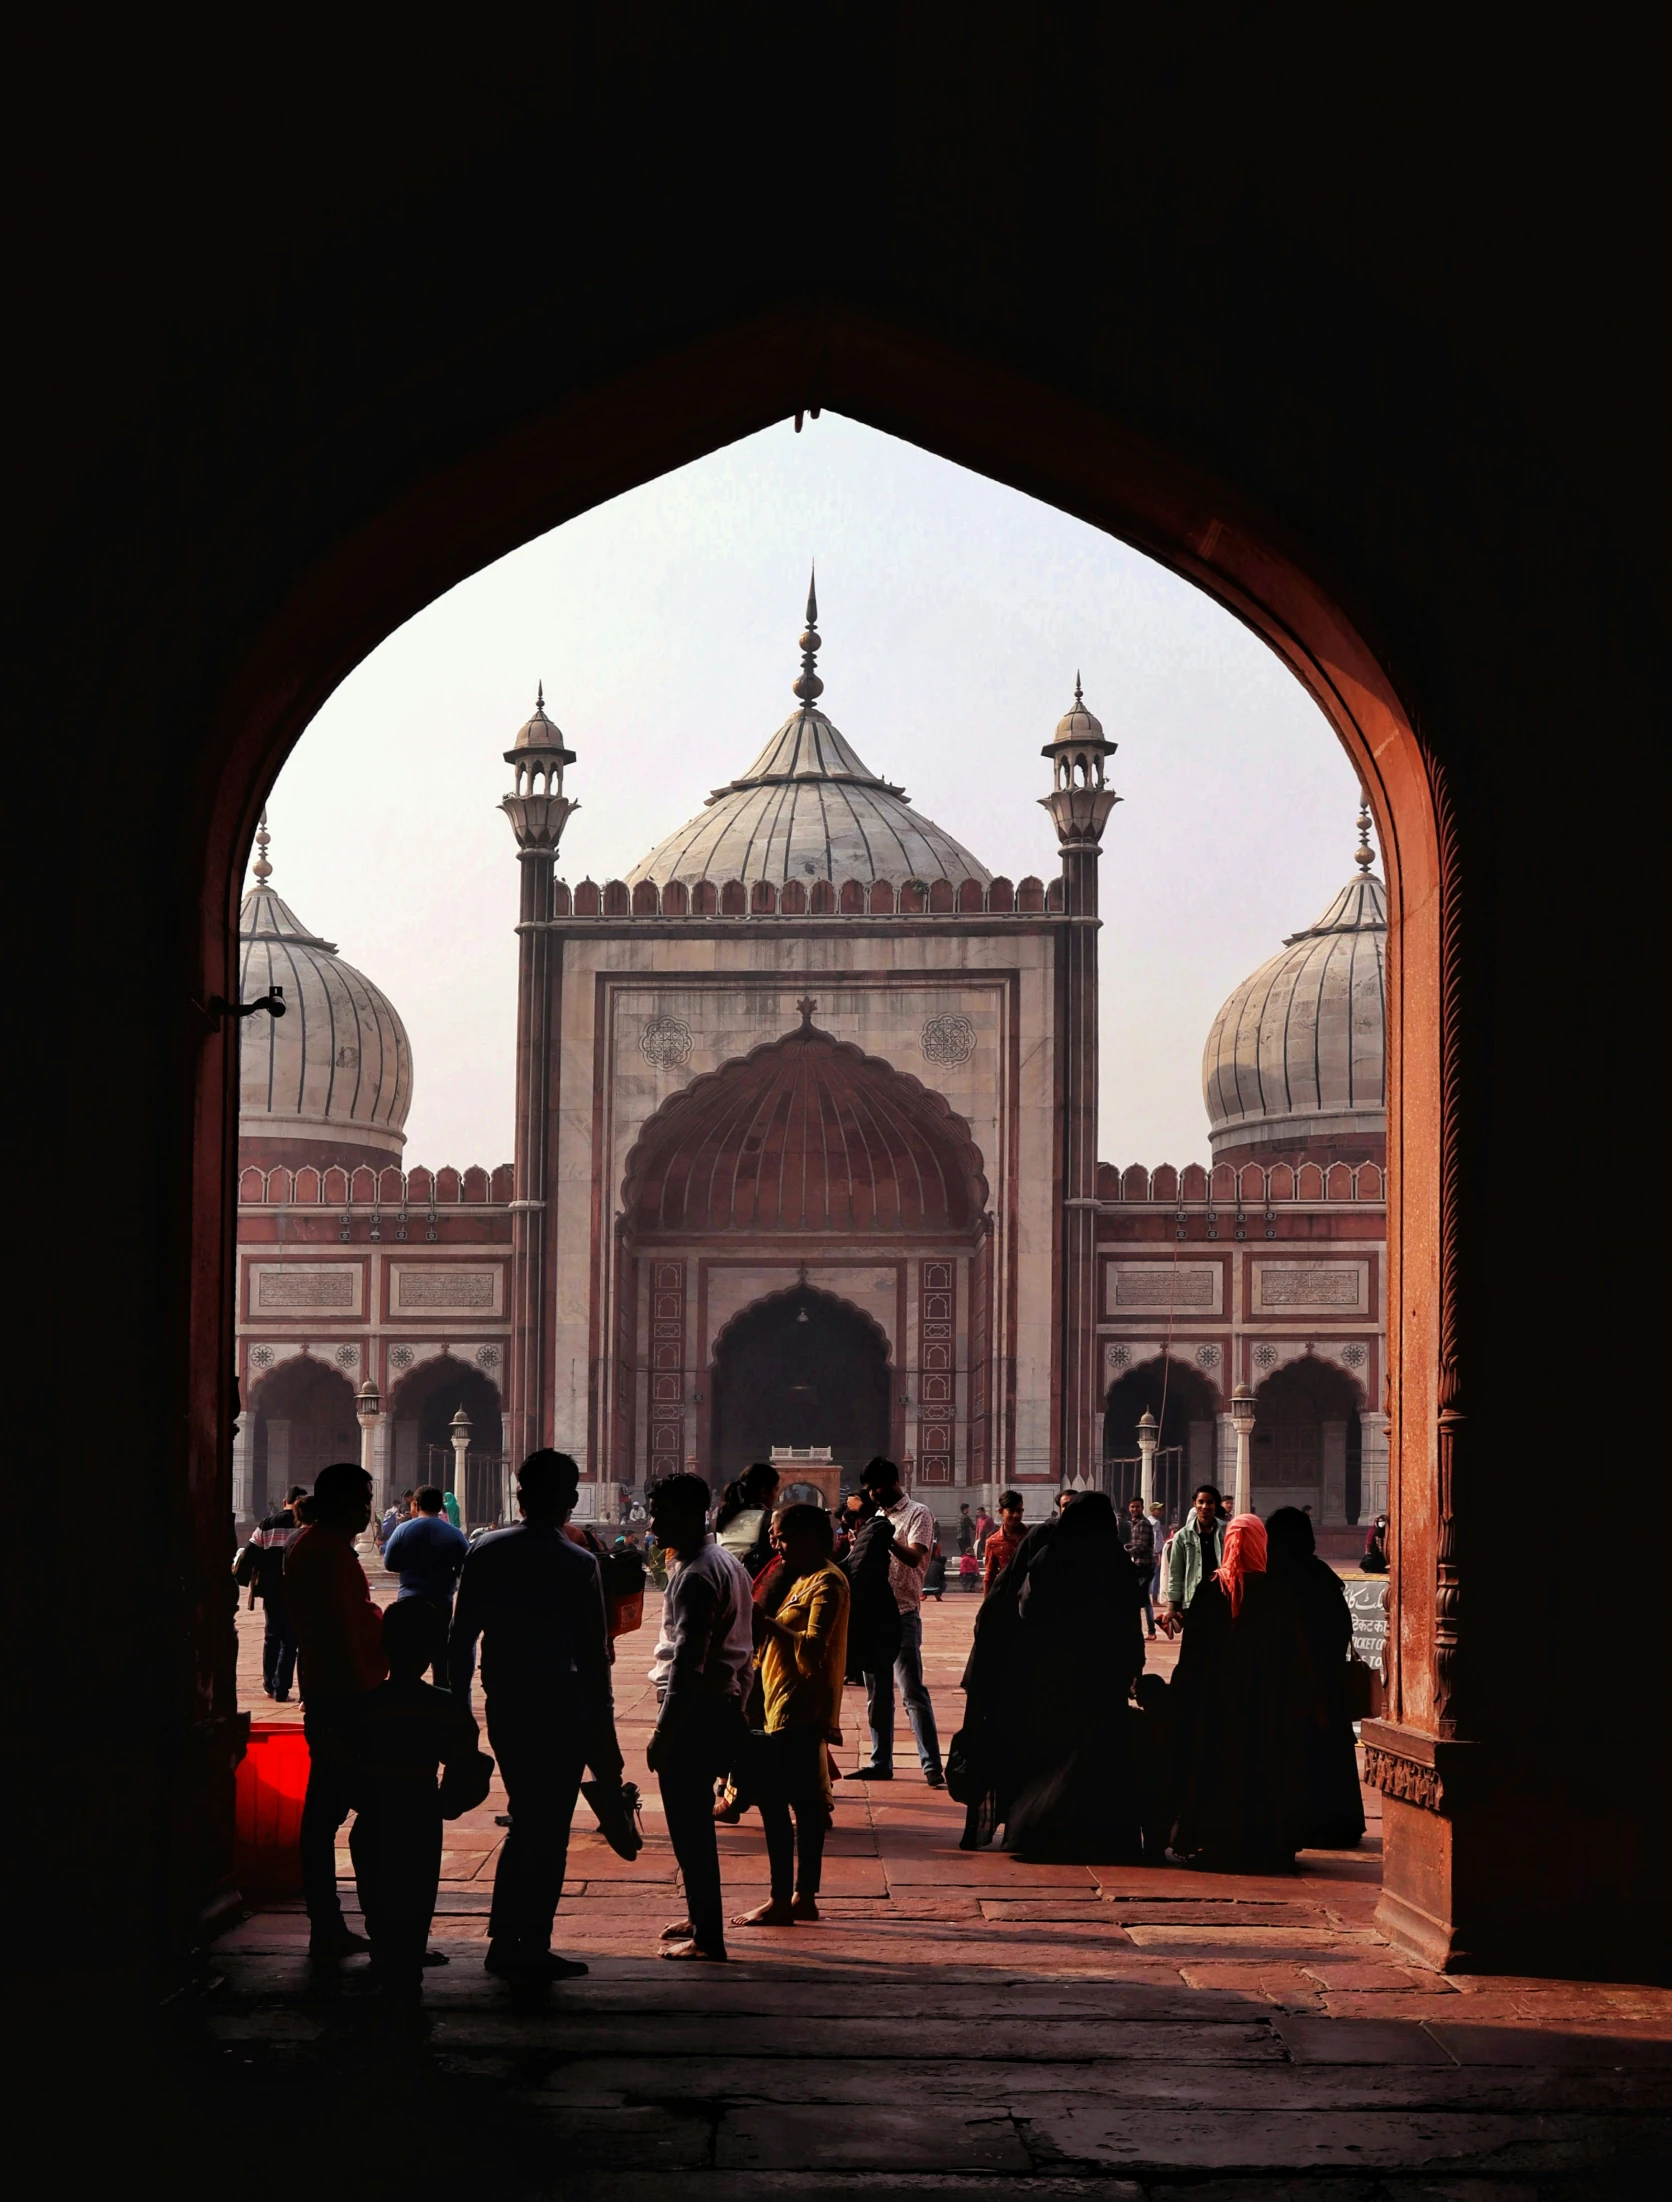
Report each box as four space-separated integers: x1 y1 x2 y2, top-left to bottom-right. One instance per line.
209 1581 1672 2202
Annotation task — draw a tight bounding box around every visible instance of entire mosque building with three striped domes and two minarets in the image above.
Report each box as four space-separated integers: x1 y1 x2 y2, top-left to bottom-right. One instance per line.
236 599 1386 1528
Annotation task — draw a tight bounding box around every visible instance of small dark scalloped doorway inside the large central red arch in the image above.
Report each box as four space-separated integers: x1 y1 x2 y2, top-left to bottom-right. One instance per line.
709 1284 892 1489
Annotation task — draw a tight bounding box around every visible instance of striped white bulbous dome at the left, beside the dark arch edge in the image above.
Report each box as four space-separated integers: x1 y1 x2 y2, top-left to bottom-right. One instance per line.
238 826 412 1163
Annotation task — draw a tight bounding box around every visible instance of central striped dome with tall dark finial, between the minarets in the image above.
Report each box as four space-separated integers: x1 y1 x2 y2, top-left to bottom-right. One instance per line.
628 595 991 885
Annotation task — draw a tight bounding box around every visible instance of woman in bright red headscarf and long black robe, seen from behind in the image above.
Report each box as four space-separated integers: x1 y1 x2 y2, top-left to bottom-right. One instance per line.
1172 1515 1313 1874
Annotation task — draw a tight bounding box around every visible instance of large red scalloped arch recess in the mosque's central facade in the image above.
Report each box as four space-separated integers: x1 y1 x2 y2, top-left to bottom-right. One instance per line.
616 998 1002 1486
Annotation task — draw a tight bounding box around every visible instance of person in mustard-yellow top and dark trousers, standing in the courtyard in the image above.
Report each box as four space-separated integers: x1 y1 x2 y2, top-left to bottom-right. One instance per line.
736 1504 848 1927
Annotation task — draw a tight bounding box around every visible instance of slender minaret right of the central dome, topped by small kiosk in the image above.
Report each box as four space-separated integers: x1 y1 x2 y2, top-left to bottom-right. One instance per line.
1040 674 1119 1482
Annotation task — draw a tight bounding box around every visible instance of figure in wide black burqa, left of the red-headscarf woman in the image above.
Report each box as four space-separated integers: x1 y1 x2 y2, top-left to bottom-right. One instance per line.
960 1491 1143 1863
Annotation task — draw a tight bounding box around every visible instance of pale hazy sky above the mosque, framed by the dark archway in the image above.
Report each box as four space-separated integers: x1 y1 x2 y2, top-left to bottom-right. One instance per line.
258 414 1357 1167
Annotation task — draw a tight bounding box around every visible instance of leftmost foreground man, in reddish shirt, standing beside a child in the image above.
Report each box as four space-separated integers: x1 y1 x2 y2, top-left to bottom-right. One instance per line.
284 1460 388 1964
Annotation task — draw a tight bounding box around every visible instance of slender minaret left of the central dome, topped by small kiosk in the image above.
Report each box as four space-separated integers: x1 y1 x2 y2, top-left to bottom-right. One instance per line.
500 683 579 1467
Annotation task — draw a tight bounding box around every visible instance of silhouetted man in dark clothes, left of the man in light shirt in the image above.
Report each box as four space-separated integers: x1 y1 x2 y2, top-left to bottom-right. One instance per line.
449 1449 621 1980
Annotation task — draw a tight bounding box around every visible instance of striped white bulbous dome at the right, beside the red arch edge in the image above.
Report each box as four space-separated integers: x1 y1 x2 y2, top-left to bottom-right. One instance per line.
1203 845 1388 1154
